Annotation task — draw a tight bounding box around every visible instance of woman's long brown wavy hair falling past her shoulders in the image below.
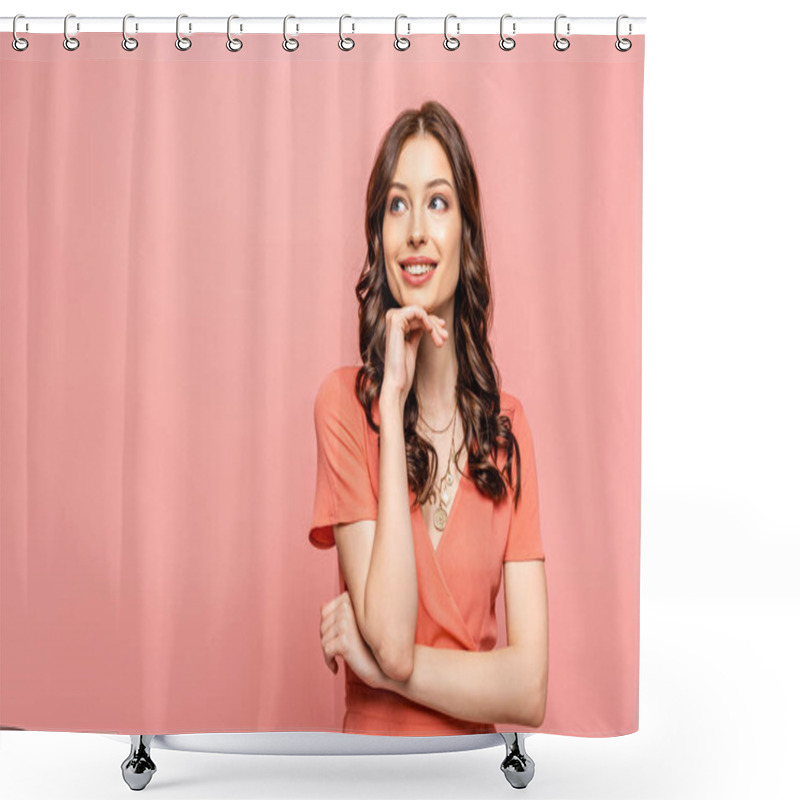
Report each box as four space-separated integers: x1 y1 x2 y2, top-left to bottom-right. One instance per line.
355 100 521 507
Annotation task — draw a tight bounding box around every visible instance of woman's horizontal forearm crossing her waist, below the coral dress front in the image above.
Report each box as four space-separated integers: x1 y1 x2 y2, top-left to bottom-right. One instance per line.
381 644 547 728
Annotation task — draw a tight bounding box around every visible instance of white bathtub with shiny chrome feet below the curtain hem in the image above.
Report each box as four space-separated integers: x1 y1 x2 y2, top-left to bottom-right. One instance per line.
101 731 535 791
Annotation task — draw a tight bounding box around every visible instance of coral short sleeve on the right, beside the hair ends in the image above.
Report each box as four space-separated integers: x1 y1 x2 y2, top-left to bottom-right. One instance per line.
503 400 544 561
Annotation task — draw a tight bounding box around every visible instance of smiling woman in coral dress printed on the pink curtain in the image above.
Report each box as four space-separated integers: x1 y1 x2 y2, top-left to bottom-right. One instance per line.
309 102 548 735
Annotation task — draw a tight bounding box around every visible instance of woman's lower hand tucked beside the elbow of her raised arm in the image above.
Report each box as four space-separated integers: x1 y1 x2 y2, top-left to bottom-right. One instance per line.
319 591 386 689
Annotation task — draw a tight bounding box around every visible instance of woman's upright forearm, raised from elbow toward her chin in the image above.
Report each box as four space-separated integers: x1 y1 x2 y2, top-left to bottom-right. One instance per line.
364 394 417 679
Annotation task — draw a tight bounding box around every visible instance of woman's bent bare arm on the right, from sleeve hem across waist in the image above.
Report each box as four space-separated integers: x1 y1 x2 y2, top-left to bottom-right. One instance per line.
372 560 548 728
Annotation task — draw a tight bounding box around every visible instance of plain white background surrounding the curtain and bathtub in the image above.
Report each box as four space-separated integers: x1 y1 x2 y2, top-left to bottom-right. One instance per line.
0 0 800 800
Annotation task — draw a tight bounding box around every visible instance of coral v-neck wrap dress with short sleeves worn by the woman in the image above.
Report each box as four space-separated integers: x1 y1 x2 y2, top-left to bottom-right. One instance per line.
308 366 544 736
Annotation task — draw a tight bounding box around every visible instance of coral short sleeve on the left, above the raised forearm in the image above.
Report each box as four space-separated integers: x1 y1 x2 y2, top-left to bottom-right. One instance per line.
308 368 378 549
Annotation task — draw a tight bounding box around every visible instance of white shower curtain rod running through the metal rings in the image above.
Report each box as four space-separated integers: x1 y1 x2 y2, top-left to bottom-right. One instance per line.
0 14 646 36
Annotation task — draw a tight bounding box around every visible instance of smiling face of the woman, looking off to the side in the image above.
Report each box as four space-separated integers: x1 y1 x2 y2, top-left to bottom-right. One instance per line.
383 134 461 319
